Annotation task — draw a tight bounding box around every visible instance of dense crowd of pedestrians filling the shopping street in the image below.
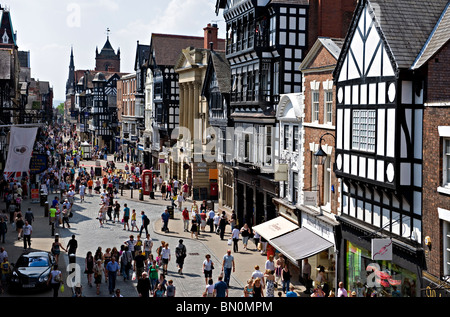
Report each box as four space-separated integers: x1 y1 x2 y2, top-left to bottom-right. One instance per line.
0 125 351 298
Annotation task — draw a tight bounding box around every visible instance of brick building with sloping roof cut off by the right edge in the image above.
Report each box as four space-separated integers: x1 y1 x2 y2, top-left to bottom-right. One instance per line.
414 6 450 296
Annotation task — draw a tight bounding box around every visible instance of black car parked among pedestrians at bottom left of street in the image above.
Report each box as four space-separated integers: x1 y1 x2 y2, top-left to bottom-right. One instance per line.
10 252 54 291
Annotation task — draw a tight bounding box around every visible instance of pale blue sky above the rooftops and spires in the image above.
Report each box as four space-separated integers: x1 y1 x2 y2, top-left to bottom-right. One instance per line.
7 0 225 101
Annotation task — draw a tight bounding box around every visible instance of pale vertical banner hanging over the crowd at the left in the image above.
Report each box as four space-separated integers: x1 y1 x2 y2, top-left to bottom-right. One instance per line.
4 127 38 173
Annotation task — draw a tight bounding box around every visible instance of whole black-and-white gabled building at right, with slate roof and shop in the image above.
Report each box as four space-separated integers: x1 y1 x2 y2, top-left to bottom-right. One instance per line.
334 0 447 296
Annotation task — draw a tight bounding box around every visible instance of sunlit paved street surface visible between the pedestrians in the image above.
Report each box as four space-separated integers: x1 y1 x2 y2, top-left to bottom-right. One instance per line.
0 157 304 298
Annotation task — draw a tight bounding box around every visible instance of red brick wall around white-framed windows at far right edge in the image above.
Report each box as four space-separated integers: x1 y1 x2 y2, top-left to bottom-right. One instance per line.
422 44 450 277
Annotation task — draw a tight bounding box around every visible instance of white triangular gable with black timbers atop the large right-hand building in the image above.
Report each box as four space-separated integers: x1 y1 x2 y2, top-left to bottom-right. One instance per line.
338 3 397 82
